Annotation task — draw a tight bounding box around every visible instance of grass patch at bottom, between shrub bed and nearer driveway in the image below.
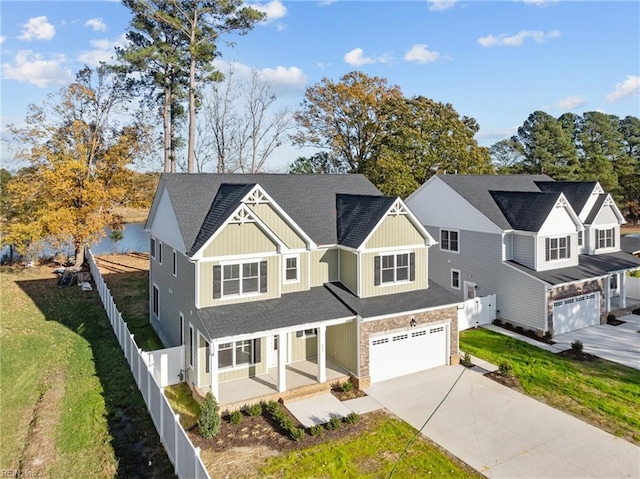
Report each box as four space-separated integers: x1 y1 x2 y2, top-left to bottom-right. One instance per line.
259 414 484 478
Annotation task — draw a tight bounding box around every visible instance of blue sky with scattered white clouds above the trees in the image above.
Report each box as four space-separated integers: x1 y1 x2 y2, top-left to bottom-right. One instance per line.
0 0 640 172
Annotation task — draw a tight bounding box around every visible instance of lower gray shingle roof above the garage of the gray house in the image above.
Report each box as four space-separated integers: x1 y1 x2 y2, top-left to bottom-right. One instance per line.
508 252 640 285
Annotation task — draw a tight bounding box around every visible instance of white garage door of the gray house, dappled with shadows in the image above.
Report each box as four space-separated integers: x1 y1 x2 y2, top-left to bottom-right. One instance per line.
553 292 600 334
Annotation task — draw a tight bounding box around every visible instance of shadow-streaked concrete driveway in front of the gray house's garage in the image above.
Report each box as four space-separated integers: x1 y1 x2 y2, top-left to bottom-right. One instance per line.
553 314 640 369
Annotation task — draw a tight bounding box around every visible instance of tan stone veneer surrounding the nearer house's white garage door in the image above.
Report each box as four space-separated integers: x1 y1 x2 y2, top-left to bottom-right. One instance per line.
353 306 460 389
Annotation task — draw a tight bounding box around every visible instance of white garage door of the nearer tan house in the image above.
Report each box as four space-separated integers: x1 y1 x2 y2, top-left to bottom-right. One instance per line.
369 324 449 383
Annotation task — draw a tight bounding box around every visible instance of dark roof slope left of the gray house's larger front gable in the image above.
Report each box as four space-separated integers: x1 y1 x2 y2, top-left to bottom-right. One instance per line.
489 191 560 231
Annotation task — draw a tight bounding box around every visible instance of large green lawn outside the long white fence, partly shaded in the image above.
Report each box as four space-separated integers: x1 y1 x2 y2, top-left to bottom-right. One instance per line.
0 267 173 478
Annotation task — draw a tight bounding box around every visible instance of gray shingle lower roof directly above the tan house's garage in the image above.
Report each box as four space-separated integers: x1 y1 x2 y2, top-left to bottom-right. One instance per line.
325 281 462 318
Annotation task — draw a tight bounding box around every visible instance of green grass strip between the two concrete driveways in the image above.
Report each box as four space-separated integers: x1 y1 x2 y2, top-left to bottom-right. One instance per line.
460 328 640 445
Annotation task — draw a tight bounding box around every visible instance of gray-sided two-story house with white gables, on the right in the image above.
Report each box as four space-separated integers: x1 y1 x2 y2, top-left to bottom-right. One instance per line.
406 175 640 335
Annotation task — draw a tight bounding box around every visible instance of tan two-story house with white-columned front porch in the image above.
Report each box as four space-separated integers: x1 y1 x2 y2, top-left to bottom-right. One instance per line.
145 174 459 402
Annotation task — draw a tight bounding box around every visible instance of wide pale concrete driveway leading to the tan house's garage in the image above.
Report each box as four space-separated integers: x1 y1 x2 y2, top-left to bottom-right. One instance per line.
366 366 640 479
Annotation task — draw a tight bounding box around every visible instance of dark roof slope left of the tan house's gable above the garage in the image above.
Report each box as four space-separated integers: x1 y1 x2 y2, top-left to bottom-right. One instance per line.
336 194 397 248
